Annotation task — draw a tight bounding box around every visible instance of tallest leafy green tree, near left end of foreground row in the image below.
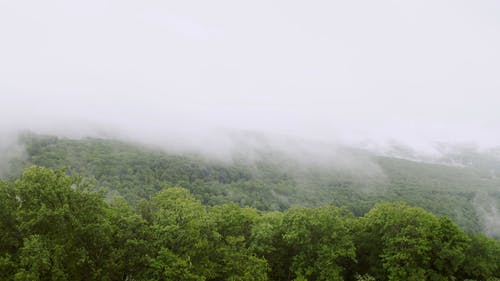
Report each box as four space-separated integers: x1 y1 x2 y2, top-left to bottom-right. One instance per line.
16 166 110 280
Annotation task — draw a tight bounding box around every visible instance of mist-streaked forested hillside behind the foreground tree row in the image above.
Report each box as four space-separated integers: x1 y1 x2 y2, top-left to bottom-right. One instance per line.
6 134 500 233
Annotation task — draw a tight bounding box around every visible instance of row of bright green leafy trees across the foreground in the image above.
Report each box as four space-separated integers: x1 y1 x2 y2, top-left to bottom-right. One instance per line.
0 166 500 281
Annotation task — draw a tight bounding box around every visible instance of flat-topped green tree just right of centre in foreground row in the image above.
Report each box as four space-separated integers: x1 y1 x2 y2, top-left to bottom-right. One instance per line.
282 207 355 280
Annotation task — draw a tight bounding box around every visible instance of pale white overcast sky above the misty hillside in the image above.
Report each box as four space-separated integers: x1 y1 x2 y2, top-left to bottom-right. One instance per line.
0 0 500 147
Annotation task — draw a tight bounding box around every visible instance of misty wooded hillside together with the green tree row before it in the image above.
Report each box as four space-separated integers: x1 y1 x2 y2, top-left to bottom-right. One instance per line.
0 133 500 281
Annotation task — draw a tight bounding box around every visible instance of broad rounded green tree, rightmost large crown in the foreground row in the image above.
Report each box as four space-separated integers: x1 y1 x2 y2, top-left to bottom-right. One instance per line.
358 204 469 280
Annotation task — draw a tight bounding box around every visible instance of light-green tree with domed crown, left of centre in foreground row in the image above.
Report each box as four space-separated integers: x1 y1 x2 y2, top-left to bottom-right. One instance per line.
149 187 215 280
